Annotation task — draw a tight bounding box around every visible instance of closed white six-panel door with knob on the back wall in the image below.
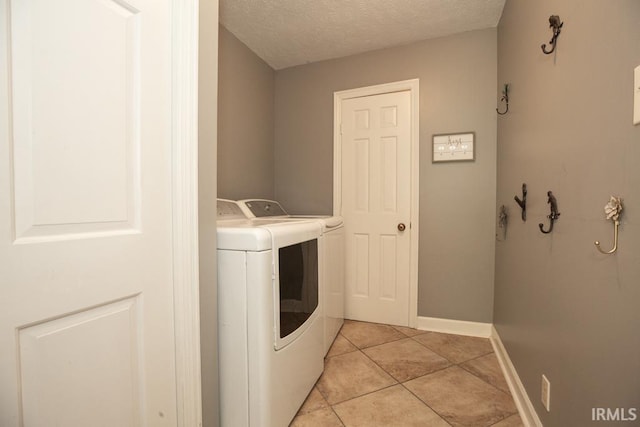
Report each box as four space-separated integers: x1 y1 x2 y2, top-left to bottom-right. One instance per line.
341 91 411 326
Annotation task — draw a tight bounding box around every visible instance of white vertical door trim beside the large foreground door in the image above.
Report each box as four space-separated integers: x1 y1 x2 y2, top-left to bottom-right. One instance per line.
170 0 202 427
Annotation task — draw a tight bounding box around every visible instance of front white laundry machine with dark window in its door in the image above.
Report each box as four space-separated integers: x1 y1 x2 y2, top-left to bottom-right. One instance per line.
217 199 324 427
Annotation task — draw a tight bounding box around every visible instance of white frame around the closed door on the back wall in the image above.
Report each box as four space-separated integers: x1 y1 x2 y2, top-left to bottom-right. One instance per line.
333 79 420 328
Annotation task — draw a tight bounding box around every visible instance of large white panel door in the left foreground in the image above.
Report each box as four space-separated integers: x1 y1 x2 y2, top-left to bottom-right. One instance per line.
0 0 177 427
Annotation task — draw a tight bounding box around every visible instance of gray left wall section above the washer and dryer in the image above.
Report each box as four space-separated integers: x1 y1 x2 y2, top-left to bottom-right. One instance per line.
218 24 274 199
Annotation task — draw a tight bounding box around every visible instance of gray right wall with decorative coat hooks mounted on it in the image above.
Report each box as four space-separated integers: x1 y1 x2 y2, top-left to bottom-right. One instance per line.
494 0 640 427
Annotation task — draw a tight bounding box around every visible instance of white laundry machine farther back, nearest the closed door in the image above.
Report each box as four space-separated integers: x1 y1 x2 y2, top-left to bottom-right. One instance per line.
238 199 345 355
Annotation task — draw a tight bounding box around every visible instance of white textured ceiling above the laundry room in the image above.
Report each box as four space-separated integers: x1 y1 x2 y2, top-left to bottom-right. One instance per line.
220 0 505 70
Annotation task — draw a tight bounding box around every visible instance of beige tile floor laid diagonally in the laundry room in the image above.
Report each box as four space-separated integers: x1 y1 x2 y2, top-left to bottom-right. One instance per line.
291 320 523 427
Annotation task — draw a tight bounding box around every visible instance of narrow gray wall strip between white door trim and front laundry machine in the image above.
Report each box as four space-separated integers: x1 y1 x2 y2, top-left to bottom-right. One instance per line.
198 0 219 427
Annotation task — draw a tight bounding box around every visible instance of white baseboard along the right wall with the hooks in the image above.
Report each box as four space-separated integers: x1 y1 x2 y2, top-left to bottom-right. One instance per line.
490 326 543 427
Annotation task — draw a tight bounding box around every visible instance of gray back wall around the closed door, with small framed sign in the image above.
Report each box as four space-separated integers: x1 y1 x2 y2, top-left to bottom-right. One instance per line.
275 29 497 322
